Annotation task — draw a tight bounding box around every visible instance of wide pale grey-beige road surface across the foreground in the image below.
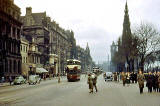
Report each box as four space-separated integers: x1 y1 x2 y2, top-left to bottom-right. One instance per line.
0 75 160 106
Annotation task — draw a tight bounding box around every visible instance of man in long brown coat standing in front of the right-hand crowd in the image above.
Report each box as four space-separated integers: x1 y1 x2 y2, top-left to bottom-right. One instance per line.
137 70 145 94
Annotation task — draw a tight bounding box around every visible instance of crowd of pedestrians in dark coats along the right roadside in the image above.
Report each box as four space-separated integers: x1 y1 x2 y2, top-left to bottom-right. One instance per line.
114 70 160 94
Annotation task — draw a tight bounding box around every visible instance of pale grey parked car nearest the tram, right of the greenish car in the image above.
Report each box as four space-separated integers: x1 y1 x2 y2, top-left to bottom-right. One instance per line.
28 75 41 85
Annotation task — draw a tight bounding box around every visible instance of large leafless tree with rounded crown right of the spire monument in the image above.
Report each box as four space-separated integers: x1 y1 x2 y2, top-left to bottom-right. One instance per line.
134 23 160 71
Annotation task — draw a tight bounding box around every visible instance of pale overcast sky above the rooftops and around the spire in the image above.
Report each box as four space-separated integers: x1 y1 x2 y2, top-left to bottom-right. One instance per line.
15 0 160 63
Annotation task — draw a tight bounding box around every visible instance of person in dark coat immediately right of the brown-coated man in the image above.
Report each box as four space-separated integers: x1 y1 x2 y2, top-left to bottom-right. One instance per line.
146 72 153 93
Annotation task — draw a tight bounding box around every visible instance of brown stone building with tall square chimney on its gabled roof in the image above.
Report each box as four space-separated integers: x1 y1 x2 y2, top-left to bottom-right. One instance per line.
21 7 49 64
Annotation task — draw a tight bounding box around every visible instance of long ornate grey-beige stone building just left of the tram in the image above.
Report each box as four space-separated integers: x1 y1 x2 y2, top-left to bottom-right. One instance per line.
49 21 71 74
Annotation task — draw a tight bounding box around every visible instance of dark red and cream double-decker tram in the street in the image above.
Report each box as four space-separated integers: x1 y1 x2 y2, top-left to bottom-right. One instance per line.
66 59 81 81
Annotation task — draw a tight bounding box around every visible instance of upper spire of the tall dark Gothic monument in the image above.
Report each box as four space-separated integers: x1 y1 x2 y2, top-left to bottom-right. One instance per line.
122 1 131 44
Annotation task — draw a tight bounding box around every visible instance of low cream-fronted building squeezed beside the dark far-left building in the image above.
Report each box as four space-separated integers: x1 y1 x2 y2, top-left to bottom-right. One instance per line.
21 35 42 77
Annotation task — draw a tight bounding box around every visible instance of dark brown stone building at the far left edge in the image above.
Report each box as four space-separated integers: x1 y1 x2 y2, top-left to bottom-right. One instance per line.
0 0 22 79
